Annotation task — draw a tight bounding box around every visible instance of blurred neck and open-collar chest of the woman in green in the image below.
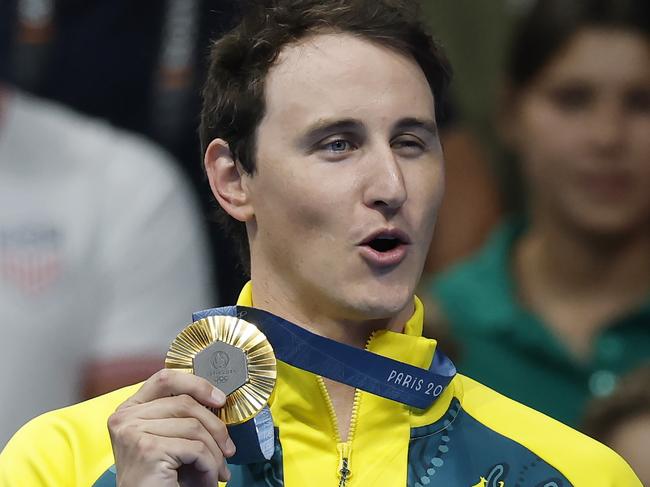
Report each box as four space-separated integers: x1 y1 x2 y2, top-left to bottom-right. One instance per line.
514 220 650 360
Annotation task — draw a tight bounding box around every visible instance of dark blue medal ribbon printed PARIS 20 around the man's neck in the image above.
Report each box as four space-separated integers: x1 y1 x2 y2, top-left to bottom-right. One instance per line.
93 306 456 480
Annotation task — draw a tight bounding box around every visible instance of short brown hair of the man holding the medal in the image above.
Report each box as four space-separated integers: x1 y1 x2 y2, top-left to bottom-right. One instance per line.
199 0 451 272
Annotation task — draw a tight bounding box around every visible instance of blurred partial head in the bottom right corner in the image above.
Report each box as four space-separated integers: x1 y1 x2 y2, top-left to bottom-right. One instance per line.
582 364 650 485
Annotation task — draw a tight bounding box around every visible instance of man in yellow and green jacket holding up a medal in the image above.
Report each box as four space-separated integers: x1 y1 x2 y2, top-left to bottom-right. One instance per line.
0 0 640 487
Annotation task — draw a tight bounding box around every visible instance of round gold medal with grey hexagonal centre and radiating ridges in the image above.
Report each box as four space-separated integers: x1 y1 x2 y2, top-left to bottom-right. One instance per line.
165 316 277 424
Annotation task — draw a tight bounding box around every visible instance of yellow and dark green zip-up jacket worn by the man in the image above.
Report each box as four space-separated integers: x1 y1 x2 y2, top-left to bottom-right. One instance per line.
0 286 641 487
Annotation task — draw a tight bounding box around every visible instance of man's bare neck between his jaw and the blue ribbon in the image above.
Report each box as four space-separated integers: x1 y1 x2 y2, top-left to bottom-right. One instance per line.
251 273 414 348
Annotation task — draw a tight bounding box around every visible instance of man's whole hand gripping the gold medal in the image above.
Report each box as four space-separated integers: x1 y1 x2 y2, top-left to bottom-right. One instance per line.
108 369 235 487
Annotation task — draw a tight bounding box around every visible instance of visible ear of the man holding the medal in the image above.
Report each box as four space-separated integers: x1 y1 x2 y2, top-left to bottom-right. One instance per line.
203 139 255 222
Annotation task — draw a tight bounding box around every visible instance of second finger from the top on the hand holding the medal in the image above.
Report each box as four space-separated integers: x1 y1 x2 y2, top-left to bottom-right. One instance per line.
121 395 235 458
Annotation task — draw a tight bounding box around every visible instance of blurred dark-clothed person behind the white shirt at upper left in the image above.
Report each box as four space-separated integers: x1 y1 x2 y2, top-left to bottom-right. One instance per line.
0 0 245 302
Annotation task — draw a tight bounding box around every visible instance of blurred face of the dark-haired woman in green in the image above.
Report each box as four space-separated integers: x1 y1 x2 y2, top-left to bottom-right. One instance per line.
507 27 650 238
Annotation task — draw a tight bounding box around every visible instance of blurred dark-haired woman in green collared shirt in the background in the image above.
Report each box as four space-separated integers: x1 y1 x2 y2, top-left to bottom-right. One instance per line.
420 0 650 425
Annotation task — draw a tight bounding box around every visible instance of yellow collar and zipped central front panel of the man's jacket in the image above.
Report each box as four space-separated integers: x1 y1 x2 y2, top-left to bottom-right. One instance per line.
244 285 452 486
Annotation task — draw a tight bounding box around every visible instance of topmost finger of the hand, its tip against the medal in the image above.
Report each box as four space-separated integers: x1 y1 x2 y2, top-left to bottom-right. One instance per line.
120 369 226 408
